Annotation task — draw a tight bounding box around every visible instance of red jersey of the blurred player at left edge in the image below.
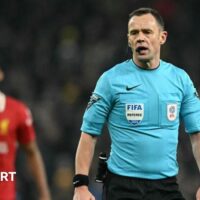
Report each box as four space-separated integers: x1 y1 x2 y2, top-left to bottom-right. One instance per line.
0 92 35 200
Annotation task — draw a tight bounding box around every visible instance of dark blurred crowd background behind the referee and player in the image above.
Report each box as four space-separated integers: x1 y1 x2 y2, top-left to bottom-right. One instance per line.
0 0 200 200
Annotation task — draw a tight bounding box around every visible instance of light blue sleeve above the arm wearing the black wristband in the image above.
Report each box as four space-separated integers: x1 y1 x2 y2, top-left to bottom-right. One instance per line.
81 74 112 135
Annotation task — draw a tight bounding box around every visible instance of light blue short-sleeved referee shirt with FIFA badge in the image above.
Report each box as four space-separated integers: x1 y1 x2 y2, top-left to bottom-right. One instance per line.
81 60 200 179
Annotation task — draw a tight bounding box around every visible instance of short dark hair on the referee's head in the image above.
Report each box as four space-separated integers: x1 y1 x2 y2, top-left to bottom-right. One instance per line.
129 8 165 30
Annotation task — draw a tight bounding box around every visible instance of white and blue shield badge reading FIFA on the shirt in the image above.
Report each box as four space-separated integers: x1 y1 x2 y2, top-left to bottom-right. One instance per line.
126 103 144 125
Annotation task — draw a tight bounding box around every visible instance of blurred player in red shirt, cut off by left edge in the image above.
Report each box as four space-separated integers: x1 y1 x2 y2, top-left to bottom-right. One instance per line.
0 67 50 200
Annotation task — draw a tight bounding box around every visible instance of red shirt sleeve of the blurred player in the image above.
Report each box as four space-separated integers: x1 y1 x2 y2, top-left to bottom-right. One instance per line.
17 104 35 144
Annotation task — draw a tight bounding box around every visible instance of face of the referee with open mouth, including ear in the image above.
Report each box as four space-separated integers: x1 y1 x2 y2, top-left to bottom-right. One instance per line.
128 14 167 63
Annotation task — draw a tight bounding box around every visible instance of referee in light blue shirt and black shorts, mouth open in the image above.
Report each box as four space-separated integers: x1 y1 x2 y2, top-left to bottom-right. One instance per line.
73 8 200 200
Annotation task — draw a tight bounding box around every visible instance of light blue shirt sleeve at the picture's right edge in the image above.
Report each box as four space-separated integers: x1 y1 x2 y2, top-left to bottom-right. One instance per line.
181 74 200 134
